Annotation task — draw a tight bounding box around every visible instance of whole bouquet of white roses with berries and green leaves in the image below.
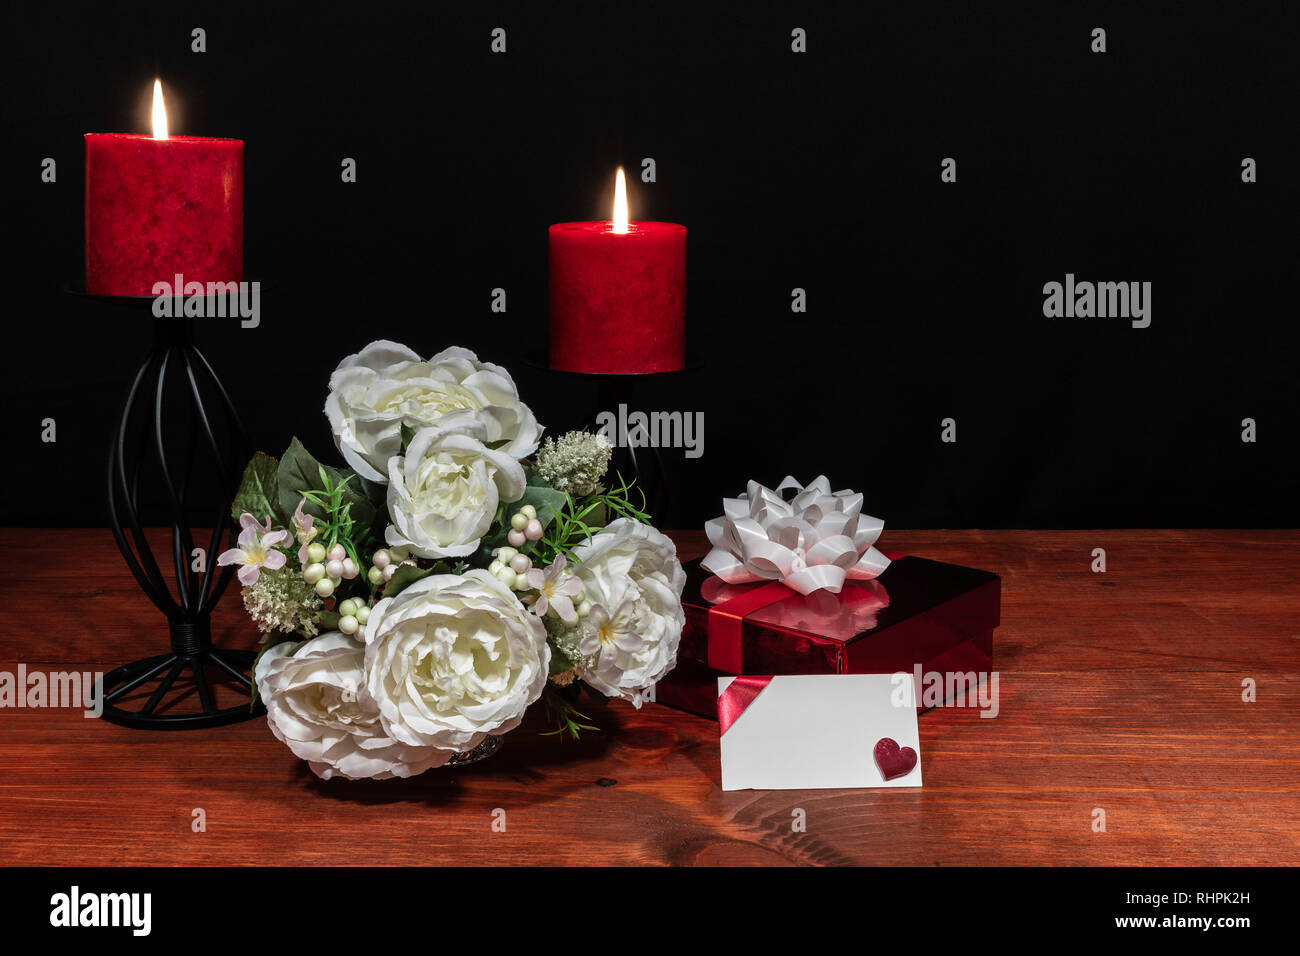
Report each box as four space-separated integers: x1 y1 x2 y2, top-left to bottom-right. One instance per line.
227 341 685 779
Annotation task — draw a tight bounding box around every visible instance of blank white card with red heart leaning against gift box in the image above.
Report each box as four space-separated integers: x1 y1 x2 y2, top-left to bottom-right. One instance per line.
718 674 920 790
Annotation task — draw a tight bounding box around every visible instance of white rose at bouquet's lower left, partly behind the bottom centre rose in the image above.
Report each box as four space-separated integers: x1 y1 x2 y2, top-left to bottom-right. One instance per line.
255 631 451 780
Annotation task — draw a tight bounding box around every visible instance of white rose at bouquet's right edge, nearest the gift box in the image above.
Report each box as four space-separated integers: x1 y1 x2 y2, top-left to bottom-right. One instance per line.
573 518 686 708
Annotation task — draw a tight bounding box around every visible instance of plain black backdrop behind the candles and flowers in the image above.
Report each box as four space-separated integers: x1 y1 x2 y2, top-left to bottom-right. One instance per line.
0 1 1300 527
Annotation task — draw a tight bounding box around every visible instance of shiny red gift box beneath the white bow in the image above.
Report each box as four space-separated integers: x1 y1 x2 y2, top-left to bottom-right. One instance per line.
654 555 1002 719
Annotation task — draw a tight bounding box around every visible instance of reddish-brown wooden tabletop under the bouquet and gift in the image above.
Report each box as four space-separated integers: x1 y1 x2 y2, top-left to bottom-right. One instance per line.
0 529 1300 865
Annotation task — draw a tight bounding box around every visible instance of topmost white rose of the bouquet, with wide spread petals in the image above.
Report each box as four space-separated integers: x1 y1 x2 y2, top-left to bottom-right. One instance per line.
325 339 542 484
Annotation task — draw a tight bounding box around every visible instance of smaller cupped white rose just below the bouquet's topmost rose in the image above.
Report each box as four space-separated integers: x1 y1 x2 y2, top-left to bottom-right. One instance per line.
384 421 528 558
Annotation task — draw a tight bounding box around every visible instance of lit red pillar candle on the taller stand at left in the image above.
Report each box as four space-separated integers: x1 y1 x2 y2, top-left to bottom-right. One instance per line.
86 85 243 295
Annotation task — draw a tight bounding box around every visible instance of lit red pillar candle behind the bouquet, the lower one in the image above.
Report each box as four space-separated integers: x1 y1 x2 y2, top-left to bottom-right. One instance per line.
550 169 686 373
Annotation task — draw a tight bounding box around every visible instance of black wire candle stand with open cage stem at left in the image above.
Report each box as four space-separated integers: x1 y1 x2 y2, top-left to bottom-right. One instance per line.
75 287 261 730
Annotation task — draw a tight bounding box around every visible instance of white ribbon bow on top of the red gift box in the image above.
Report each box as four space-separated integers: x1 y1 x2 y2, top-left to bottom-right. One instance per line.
699 475 889 594
